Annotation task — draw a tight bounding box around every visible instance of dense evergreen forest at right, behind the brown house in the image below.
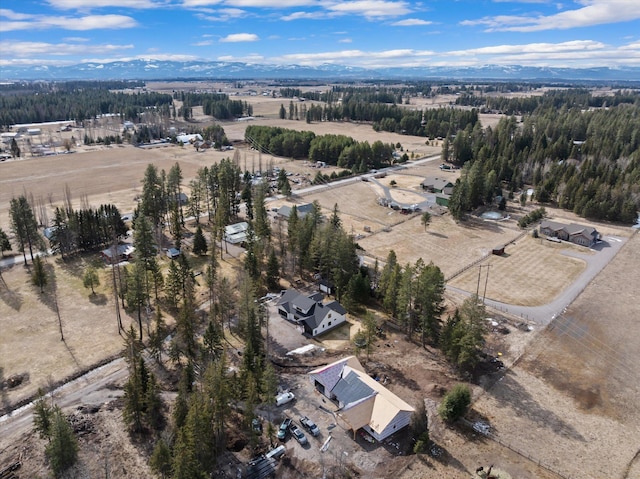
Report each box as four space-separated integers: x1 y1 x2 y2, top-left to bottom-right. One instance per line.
442 91 640 224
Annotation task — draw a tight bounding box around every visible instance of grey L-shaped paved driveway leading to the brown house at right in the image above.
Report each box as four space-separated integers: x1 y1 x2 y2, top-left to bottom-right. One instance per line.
447 236 628 326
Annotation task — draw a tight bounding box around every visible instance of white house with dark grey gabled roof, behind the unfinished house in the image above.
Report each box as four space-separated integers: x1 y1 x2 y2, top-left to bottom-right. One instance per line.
277 289 347 337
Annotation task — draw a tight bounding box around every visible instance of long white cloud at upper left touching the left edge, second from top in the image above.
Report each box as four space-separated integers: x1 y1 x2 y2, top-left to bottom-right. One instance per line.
0 10 138 32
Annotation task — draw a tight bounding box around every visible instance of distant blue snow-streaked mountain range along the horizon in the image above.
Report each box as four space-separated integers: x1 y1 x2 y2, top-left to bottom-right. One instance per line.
0 60 640 84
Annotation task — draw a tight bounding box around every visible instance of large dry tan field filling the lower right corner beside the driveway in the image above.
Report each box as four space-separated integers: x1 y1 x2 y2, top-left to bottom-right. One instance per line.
474 234 640 479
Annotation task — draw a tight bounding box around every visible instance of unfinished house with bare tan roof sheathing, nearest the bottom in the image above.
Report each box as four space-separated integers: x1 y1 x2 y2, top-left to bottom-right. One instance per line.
309 356 414 441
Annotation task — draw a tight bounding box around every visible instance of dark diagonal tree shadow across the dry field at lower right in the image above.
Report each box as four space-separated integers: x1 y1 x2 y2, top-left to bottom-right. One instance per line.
487 371 585 442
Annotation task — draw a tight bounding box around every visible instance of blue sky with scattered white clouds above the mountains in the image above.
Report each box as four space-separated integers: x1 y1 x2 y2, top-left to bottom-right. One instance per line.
0 0 640 69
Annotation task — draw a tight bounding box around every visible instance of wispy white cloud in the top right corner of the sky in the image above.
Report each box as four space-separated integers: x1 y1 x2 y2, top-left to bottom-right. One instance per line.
461 0 640 32
